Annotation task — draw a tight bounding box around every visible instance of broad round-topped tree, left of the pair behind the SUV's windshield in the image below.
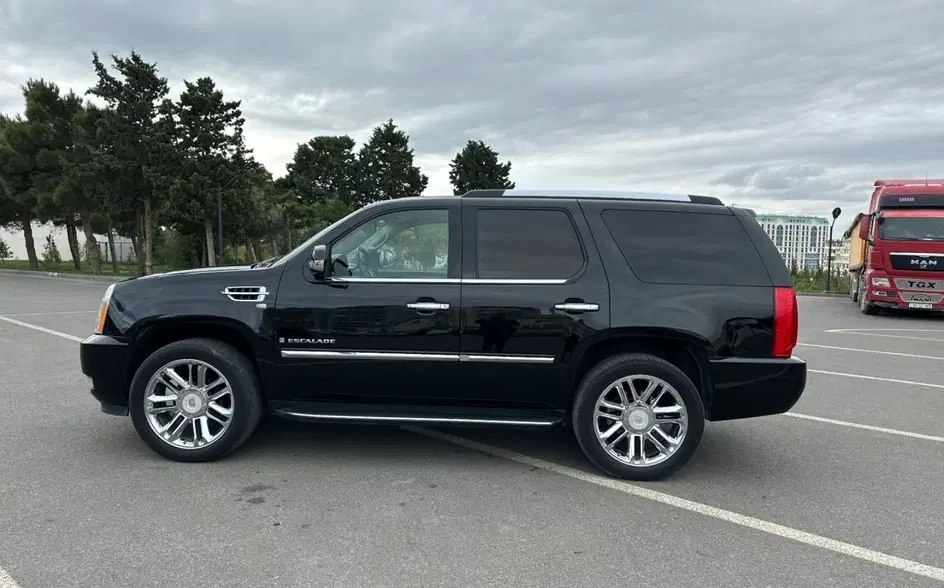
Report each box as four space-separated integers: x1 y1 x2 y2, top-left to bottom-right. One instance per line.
286 135 358 205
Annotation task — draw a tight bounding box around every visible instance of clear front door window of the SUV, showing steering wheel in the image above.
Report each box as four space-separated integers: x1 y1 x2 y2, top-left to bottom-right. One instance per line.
331 209 449 280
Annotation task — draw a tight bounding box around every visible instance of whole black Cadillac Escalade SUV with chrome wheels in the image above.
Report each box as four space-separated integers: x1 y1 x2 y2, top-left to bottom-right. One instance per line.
81 190 806 480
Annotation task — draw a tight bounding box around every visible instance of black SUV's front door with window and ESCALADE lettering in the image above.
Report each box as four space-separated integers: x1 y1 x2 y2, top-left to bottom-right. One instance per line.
275 205 461 404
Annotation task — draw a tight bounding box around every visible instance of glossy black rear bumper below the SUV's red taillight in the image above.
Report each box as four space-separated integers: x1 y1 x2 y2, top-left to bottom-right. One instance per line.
708 357 806 421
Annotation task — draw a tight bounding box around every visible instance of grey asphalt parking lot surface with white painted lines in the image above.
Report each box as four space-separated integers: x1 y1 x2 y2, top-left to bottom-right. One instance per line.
0 274 944 588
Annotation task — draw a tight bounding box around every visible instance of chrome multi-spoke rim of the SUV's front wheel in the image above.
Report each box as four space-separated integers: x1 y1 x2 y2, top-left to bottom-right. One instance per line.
144 359 233 449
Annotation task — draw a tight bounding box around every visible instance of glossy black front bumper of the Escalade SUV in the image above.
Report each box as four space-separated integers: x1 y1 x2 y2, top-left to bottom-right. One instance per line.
79 335 129 416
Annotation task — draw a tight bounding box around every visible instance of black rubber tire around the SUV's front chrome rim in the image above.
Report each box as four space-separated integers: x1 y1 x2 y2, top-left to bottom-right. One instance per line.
129 338 263 462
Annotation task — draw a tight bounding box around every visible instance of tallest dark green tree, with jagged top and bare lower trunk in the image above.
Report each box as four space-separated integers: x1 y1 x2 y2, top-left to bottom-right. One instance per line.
88 51 174 274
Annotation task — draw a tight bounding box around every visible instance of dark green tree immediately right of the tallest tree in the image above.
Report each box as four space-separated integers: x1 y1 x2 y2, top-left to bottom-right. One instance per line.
164 77 250 266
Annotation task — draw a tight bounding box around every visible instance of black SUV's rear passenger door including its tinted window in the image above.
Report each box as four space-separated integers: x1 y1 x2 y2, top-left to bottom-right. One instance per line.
458 198 610 408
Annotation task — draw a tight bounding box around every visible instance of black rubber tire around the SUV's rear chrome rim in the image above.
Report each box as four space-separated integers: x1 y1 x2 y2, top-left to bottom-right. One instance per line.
572 353 705 481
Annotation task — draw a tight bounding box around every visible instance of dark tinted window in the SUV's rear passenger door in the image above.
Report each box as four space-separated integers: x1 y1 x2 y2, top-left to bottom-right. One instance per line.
476 208 583 280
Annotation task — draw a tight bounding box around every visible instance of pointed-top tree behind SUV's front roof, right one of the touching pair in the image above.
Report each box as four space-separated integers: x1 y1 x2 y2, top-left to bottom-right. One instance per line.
352 119 429 206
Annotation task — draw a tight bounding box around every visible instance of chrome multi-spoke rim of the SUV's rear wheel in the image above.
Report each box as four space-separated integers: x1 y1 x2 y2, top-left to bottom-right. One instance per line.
593 375 688 467
